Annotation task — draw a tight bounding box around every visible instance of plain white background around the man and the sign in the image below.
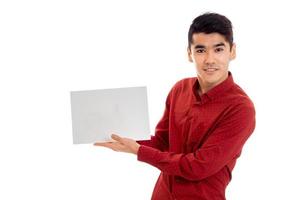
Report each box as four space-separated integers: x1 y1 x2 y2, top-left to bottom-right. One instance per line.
0 0 300 200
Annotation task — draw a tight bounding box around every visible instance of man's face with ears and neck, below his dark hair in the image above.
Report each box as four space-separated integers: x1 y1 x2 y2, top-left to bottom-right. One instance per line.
188 33 235 92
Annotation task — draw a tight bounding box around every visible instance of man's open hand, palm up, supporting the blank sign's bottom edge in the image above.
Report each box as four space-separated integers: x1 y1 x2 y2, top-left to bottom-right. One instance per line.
94 134 140 154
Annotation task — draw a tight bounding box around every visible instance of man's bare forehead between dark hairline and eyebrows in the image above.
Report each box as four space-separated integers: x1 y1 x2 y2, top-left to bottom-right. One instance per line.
191 33 229 47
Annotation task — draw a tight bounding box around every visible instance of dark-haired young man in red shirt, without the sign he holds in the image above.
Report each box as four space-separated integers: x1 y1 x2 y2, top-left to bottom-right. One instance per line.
95 13 255 200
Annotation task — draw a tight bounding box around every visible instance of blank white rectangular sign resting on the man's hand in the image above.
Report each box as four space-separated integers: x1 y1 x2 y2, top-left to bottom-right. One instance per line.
71 87 150 144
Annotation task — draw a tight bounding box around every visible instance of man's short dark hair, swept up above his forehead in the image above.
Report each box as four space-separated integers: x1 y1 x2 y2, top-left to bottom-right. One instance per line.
188 13 233 48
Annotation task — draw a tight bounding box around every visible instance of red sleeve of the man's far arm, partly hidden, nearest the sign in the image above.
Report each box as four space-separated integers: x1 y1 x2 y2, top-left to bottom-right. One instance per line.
137 90 172 151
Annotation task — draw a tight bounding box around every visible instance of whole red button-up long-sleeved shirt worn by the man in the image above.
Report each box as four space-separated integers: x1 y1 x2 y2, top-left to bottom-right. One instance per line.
137 72 255 200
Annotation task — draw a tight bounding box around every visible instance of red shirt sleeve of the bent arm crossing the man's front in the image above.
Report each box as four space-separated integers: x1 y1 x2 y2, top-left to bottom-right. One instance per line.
137 103 255 181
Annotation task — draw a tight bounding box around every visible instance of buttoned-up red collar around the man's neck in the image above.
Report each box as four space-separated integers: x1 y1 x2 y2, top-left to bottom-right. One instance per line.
193 72 234 103
